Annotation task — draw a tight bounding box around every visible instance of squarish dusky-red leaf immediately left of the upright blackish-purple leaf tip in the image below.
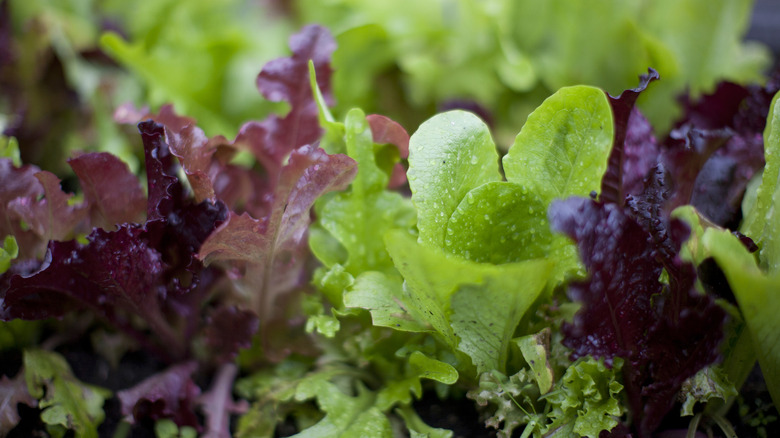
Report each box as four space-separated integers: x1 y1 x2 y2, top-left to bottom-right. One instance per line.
68 152 146 229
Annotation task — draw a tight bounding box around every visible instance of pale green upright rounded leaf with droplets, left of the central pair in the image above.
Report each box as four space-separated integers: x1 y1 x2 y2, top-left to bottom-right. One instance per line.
407 110 501 247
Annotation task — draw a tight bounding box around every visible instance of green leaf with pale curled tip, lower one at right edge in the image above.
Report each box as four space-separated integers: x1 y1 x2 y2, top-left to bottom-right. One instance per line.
702 228 780 406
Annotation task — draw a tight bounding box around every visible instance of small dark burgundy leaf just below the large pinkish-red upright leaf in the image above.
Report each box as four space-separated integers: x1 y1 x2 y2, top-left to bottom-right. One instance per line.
205 306 259 363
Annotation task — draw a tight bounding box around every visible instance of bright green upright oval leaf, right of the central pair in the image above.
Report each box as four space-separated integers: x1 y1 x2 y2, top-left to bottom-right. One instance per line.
503 86 613 204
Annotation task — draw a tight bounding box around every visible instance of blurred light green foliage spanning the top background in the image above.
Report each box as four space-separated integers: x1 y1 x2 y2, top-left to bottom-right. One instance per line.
0 0 772 175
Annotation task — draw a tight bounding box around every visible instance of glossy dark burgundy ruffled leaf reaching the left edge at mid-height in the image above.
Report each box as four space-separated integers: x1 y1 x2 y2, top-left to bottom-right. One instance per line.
0 225 171 350
